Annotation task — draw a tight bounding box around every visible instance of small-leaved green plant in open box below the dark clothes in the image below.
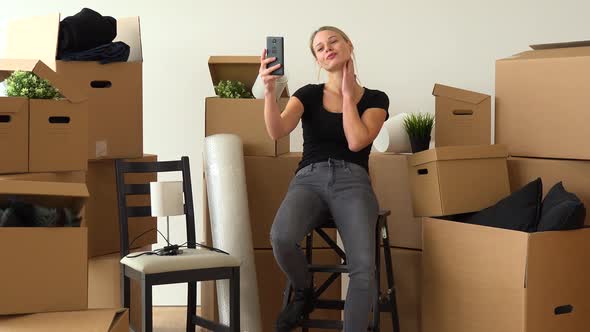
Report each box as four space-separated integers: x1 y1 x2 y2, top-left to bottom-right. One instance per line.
6 70 63 99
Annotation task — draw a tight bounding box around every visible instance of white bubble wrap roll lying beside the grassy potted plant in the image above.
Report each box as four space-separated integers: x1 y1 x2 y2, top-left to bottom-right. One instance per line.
373 113 412 153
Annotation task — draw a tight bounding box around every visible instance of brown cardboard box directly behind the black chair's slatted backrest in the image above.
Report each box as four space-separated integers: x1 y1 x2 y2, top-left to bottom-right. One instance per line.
85 155 157 257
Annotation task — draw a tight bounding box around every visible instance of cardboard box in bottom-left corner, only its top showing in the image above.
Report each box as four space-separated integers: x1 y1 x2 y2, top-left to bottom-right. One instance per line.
0 309 129 332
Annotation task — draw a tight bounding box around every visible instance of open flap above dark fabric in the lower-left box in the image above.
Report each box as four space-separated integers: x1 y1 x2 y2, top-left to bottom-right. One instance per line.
0 180 89 211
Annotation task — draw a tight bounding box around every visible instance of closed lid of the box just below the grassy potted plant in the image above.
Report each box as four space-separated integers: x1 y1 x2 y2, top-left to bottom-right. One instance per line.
408 144 508 166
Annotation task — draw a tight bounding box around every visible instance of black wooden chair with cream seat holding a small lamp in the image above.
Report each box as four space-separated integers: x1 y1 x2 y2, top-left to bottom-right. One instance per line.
115 157 240 332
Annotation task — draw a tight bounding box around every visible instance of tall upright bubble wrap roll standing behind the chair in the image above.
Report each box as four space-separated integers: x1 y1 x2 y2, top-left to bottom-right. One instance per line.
205 134 262 332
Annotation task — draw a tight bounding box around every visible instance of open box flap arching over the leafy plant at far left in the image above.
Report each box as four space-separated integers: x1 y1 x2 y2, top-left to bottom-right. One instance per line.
0 58 86 103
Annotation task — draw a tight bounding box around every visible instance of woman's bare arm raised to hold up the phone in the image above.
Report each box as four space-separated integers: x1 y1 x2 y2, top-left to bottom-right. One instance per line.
259 50 303 140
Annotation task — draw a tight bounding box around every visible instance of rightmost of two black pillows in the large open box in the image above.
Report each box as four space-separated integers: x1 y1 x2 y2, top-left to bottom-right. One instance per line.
537 182 586 232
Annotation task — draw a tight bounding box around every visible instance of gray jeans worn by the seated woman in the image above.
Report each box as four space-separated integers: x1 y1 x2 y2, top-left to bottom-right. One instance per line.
270 159 379 332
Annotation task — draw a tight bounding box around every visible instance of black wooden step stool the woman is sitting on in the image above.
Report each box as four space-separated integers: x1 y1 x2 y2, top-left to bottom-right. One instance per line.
283 210 400 332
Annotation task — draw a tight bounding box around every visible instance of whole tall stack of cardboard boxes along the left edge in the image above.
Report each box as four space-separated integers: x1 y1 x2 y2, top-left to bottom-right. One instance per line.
0 14 156 331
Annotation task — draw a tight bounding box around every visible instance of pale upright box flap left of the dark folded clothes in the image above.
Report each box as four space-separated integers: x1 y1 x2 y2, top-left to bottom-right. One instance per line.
4 14 60 71
